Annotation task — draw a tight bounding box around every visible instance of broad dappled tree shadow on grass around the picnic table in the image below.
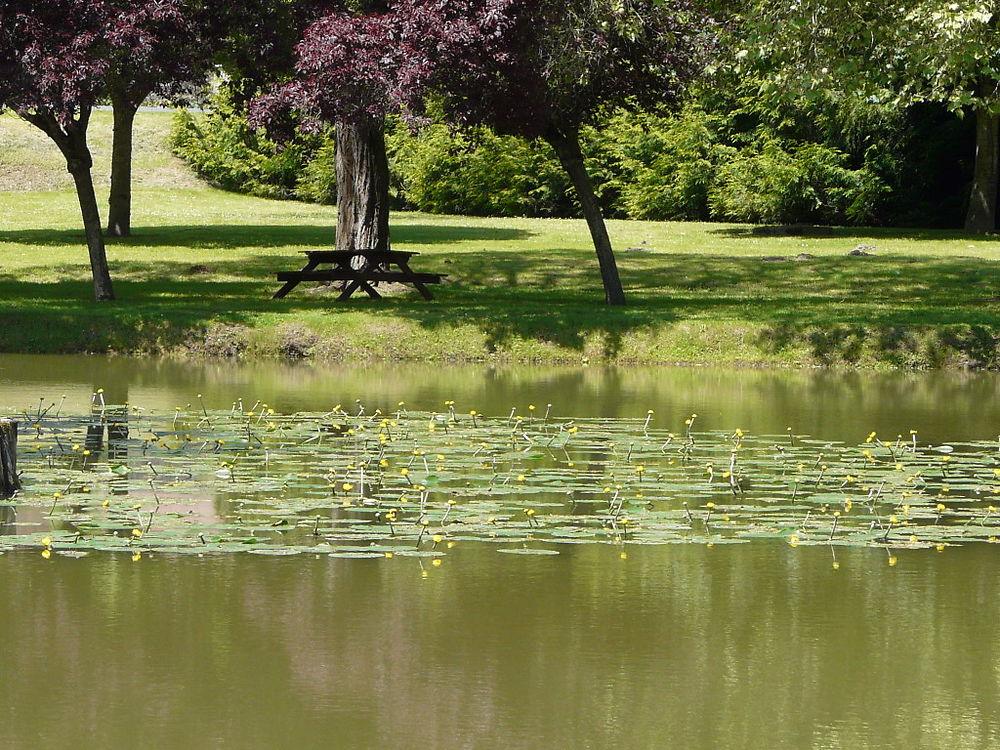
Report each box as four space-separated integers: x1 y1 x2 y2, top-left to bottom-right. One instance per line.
0 247 1000 362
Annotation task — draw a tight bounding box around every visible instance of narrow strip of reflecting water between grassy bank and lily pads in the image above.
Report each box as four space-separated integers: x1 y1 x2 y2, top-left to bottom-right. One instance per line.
0 355 1000 442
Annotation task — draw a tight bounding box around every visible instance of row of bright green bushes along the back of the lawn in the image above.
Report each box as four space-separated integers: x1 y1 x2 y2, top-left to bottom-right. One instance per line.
173 81 971 226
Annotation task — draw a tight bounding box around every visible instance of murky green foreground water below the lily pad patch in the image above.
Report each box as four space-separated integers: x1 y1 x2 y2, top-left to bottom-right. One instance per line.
0 545 1000 750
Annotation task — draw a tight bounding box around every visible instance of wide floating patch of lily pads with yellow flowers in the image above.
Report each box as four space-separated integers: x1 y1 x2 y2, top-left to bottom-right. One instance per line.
9 408 1000 555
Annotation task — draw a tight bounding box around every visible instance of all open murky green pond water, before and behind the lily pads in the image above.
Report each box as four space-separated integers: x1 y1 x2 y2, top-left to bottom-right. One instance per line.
0 356 1000 750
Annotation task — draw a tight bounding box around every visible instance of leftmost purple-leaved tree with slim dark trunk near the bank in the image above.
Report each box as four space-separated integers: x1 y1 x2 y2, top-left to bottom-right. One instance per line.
0 0 114 301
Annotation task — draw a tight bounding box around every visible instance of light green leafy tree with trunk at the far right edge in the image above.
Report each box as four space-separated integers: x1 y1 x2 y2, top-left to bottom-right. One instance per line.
740 0 1000 232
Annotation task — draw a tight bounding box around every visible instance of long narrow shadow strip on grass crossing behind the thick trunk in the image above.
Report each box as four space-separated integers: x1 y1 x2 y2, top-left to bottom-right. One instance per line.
0 224 532 250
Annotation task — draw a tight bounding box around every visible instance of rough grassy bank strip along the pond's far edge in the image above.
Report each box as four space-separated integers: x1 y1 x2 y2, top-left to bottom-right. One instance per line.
0 318 1000 372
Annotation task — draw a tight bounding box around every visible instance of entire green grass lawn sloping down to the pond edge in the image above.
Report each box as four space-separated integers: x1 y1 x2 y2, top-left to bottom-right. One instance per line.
0 112 1000 367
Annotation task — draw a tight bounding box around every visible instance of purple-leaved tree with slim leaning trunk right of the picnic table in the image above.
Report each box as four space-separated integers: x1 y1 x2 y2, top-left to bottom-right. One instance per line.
254 0 712 305
